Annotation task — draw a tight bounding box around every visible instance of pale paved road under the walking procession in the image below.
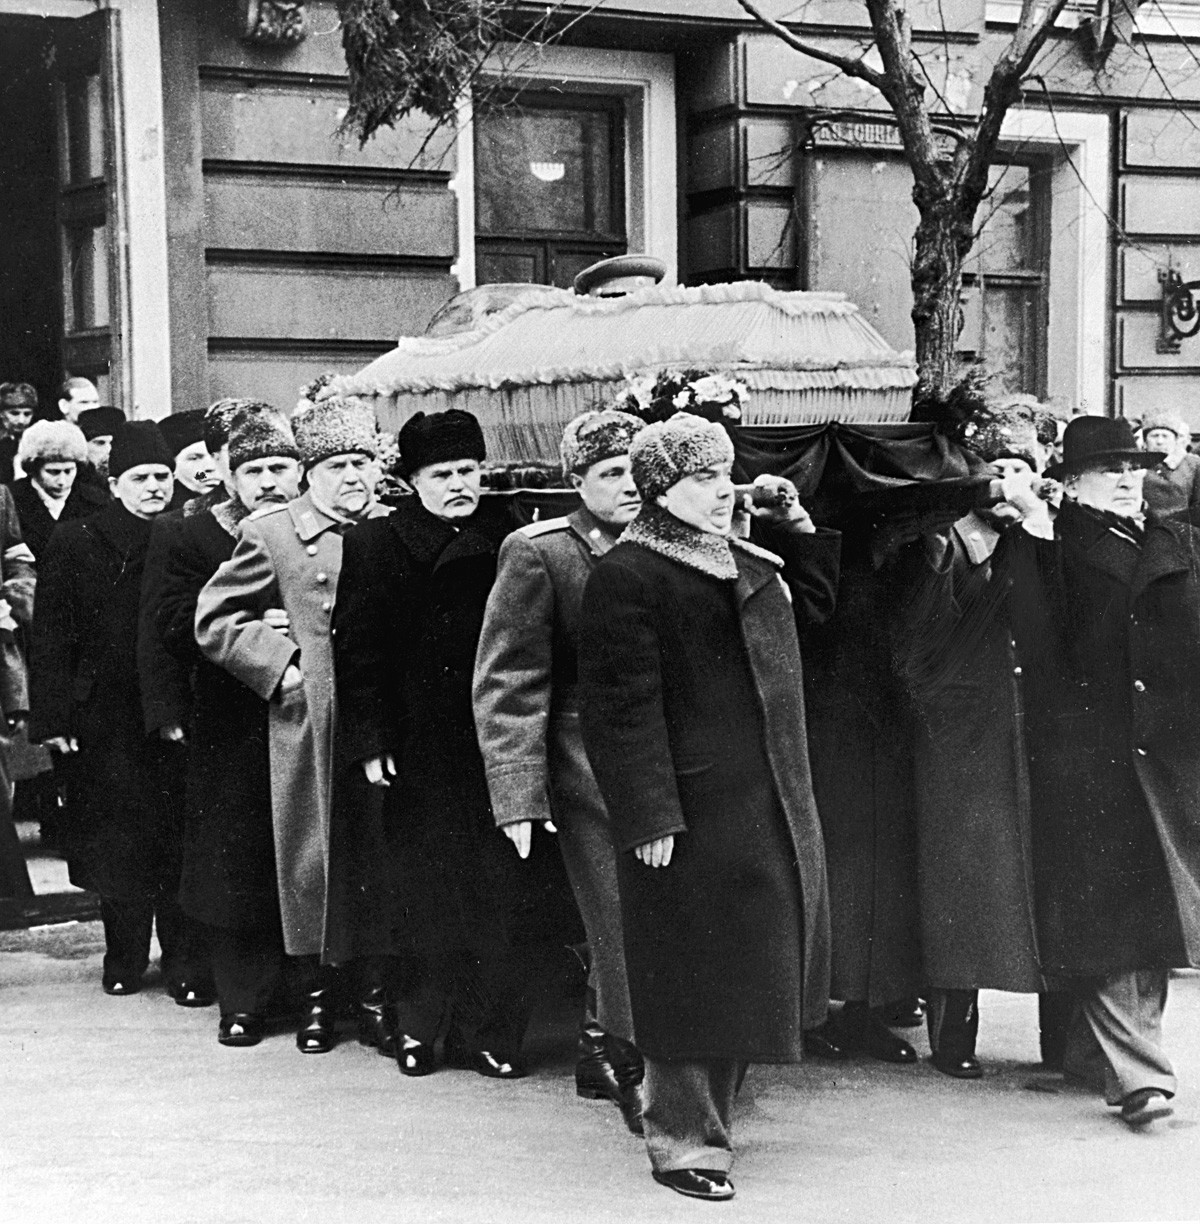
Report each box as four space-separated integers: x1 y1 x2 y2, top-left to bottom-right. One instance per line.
0 923 1200 1224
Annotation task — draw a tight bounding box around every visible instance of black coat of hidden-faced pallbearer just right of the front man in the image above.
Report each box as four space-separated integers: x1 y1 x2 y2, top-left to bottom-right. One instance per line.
801 543 921 1005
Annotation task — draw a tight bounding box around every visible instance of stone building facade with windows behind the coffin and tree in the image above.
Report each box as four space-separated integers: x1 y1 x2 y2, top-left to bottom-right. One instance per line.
7 0 1200 431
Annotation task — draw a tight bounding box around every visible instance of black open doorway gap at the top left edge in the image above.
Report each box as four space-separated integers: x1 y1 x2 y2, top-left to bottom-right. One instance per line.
0 18 62 411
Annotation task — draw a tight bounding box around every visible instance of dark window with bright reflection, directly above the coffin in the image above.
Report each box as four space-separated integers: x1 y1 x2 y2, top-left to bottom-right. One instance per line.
475 93 628 288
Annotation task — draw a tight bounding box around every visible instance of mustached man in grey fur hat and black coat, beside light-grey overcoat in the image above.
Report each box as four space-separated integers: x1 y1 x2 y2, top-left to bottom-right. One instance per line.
137 399 300 1023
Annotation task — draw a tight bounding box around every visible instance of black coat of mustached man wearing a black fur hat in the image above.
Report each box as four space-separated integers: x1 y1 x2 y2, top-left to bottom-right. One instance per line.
333 497 578 956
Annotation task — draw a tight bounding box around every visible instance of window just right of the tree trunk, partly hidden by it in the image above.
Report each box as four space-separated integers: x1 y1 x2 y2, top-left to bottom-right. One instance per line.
959 160 1051 397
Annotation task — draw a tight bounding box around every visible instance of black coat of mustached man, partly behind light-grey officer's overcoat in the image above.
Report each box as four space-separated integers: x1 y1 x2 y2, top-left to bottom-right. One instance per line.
151 501 279 930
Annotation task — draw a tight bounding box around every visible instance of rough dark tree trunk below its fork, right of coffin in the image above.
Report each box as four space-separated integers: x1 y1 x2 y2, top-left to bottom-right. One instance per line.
912 192 973 400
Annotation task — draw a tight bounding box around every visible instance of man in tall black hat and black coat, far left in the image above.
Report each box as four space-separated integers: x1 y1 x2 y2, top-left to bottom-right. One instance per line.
31 421 208 995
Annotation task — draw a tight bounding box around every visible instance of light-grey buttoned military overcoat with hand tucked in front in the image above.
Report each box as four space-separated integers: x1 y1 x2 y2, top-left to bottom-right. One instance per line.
196 493 387 956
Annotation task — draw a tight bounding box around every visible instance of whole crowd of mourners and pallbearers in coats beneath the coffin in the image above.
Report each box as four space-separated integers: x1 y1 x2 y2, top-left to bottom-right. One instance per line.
0 378 1200 1200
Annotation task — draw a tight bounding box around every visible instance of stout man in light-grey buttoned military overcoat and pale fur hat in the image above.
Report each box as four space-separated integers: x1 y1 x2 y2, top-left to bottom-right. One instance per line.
196 398 387 1054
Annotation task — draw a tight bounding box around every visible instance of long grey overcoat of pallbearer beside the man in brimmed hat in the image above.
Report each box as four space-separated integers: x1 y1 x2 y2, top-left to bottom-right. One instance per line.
898 514 1043 991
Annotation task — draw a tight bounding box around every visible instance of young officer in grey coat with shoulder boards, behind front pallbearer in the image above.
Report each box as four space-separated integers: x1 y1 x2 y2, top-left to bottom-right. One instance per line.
474 411 645 1133
